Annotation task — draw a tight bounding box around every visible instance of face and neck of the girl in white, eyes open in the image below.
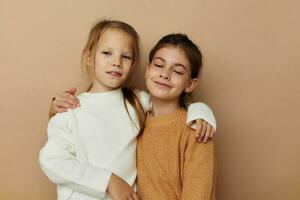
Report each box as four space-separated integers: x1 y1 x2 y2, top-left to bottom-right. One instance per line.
91 28 133 92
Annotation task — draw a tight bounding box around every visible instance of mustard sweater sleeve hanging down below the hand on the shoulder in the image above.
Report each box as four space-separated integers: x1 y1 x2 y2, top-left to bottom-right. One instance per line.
181 130 215 200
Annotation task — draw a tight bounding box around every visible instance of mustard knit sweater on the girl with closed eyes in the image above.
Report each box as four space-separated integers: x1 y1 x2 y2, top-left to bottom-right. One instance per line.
137 109 215 200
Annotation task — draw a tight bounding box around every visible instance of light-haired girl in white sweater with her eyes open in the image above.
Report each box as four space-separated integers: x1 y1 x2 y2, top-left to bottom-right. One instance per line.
40 20 215 200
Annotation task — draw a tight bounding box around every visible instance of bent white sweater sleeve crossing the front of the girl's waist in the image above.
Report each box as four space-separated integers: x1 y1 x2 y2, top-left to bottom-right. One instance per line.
39 112 111 198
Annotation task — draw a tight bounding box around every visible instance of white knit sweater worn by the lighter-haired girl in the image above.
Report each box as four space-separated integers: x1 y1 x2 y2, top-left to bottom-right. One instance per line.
39 89 216 200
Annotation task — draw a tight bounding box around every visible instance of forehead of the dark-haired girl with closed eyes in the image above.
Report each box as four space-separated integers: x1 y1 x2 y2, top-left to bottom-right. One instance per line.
154 46 190 67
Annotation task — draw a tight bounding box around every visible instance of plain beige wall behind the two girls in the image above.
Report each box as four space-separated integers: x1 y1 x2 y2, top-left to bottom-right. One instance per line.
0 0 300 200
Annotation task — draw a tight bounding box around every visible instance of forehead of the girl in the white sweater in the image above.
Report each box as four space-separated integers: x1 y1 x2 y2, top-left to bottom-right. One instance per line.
98 28 133 49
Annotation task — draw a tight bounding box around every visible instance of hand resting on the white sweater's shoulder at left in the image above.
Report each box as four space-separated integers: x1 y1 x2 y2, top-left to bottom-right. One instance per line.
50 88 80 115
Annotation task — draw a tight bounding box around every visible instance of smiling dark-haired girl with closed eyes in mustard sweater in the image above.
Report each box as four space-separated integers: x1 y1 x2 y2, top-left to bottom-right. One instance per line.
137 34 215 200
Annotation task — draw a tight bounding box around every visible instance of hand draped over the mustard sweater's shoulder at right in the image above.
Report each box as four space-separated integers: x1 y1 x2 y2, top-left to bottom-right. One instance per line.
196 119 215 143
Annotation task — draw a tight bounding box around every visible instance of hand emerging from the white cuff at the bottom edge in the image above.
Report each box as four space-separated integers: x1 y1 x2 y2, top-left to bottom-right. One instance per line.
107 174 138 200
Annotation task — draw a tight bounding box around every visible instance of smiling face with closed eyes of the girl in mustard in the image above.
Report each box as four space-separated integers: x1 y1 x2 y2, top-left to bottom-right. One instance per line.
145 46 197 101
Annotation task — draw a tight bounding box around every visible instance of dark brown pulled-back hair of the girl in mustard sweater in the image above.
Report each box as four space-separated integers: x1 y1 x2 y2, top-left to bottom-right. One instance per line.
149 33 202 107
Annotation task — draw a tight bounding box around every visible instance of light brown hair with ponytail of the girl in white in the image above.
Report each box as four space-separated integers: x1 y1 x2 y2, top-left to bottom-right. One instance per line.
82 20 145 131
